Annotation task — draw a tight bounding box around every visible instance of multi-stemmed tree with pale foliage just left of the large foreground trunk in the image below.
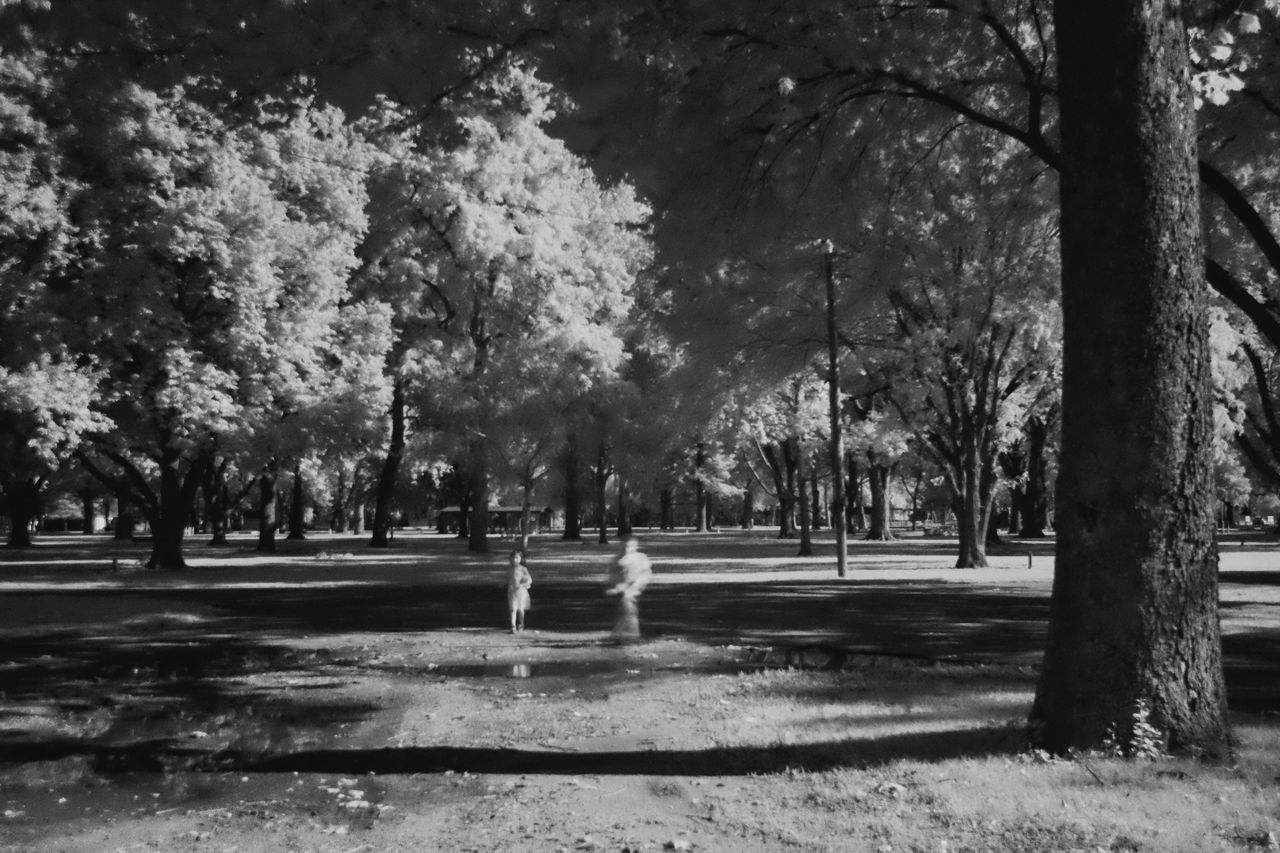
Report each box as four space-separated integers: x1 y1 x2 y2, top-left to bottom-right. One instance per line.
882 134 1060 567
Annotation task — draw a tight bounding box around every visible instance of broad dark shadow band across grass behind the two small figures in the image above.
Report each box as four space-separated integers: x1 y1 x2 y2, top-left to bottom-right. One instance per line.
0 580 1048 660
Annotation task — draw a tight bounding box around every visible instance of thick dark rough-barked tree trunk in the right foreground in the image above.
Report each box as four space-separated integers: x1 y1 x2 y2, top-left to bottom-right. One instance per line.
1032 0 1229 754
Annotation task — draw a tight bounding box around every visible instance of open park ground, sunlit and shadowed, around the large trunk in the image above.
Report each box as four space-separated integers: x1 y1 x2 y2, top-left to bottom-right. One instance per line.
0 530 1280 853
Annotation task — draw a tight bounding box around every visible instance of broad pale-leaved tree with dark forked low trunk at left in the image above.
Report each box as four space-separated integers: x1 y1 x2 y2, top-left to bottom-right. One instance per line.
60 85 365 567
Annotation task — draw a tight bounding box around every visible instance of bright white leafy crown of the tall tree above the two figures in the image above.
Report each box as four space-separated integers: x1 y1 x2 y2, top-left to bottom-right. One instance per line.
361 65 650 445
